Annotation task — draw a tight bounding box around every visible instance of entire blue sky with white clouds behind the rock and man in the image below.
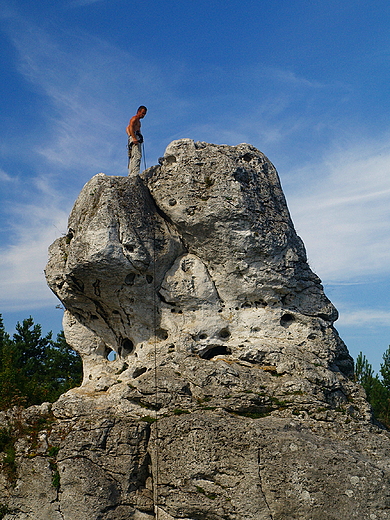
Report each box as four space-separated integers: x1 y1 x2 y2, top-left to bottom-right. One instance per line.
0 0 390 370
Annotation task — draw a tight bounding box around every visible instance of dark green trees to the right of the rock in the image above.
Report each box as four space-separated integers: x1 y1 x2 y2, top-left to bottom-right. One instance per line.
355 346 390 429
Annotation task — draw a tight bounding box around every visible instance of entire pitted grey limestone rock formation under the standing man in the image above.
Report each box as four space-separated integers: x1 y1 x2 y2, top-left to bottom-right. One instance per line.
0 139 390 520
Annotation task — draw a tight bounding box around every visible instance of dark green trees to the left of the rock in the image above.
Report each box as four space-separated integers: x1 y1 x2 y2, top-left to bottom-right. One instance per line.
0 314 82 410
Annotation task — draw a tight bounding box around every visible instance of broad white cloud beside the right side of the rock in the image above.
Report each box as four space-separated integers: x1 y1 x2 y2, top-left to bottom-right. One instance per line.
288 136 390 282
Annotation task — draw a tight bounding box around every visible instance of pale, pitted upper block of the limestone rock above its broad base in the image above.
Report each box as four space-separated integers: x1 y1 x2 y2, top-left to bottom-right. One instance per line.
46 139 352 385
